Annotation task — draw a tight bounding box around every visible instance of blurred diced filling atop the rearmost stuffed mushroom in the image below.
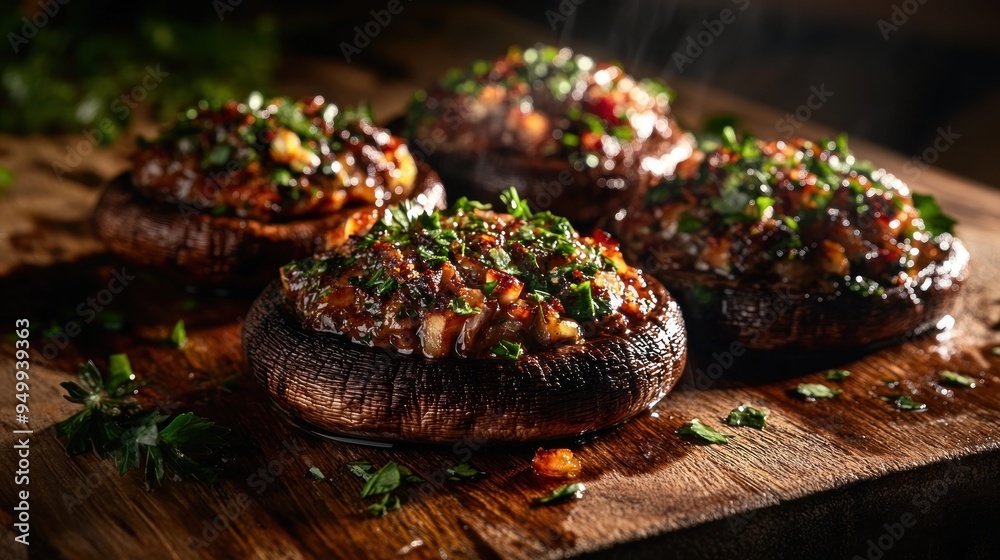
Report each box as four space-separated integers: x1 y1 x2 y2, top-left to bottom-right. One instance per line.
410 47 682 174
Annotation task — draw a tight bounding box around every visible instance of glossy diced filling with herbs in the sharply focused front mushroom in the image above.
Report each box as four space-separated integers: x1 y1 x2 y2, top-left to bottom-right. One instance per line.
281 189 657 359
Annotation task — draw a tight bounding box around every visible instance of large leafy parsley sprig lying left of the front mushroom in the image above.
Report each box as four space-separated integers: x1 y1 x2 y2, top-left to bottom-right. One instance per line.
56 354 228 484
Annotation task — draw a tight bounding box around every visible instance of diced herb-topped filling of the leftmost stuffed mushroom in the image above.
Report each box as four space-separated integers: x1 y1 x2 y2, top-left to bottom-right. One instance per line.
132 94 417 221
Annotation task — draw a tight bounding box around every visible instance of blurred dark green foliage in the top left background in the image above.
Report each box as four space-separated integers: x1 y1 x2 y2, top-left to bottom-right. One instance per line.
0 0 278 143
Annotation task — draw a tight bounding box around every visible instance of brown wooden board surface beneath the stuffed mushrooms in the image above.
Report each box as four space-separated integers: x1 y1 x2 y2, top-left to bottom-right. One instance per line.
0 5 1000 559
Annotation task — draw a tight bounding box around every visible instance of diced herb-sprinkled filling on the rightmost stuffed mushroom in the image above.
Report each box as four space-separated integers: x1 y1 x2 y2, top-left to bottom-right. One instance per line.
622 128 954 296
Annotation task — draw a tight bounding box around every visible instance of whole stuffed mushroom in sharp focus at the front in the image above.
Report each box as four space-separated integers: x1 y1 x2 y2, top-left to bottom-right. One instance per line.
243 190 687 443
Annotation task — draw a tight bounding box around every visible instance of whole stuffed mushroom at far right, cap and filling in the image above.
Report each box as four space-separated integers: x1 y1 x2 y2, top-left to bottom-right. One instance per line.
612 128 969 351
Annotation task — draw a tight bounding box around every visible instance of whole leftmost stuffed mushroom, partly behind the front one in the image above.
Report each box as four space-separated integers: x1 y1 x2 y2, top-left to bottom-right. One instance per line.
94 95 445 294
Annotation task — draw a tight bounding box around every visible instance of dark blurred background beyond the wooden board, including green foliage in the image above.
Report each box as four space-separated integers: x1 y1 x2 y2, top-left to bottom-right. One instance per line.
0 0 1000 186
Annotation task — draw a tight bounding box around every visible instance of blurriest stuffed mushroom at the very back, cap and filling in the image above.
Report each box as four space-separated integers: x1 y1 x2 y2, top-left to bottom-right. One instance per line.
407 46 693 226
